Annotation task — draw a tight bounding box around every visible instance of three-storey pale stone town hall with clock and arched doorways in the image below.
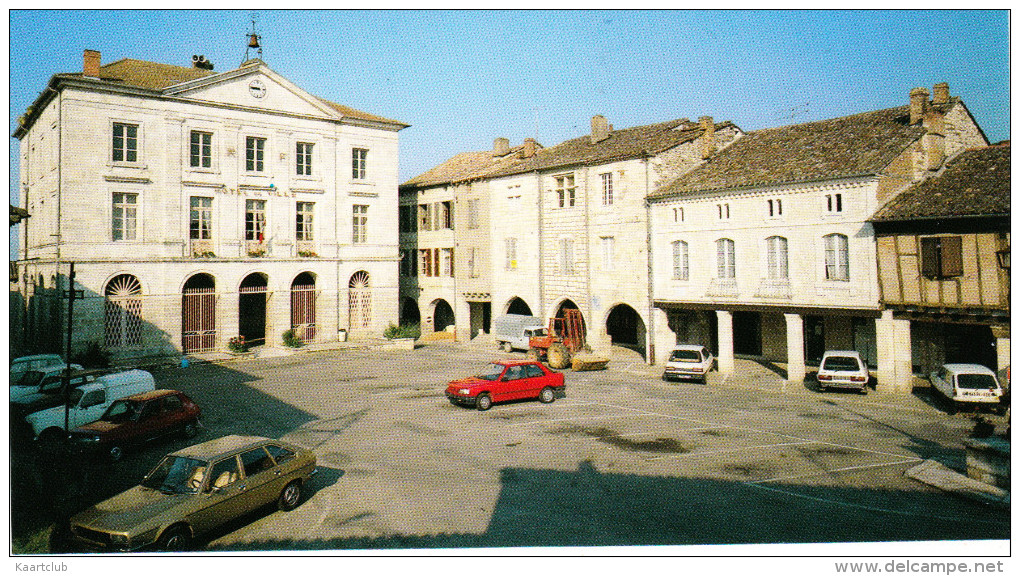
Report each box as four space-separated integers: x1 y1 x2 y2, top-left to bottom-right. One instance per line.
15 54 406 359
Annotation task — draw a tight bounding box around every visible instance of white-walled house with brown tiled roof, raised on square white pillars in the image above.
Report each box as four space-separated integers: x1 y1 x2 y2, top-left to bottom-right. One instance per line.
650 87 986 389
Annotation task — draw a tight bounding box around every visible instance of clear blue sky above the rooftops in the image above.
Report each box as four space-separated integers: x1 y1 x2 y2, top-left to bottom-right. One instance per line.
9 10 1010 253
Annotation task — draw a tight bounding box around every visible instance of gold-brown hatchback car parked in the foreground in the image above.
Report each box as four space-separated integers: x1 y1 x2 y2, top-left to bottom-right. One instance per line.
70 436 316 552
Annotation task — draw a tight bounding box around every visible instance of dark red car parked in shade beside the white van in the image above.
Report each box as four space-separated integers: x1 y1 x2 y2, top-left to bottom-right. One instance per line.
70 390 202 462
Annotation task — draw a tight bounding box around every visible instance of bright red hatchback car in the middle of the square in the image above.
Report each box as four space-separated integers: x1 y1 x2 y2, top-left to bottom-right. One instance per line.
446 360 566 410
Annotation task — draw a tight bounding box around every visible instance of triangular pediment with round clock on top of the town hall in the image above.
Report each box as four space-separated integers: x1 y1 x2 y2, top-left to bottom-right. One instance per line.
164 64 339 118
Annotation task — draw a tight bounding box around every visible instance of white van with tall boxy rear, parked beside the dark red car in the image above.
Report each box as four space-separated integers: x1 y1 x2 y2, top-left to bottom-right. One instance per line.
24 370 156 438
